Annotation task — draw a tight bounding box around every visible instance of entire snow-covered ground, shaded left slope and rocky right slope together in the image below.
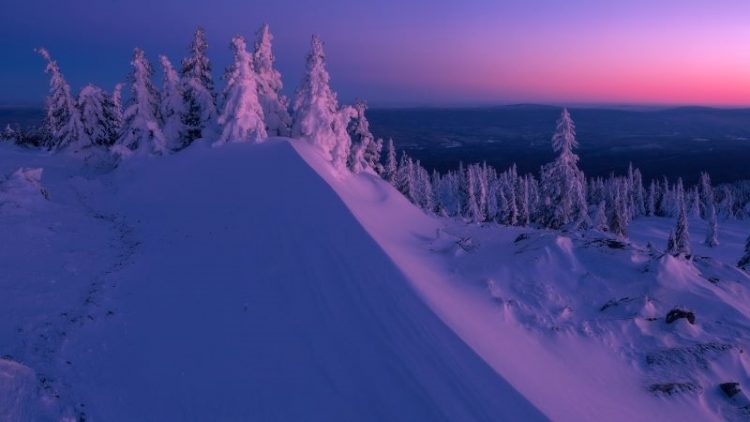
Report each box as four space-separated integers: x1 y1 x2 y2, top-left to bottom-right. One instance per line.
0 138 750 421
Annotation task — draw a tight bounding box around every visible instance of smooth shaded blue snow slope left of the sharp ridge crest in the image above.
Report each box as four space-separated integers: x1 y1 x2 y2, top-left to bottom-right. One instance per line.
0 140 545 421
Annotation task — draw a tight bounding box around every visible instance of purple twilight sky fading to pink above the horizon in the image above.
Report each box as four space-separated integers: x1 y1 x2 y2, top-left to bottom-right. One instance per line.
0 0 750 107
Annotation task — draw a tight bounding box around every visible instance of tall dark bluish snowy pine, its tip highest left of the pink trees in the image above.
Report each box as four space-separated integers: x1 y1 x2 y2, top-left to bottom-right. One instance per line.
181 28 217 147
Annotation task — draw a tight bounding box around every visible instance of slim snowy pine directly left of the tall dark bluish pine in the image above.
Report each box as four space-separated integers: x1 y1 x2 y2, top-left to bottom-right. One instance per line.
159 55 187 150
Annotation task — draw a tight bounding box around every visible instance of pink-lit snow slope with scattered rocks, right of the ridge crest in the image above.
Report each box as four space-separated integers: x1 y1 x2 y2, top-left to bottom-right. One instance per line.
294 143 750 420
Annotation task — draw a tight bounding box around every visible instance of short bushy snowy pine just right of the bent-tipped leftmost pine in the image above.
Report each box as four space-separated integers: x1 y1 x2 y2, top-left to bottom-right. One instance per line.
78 84 118 146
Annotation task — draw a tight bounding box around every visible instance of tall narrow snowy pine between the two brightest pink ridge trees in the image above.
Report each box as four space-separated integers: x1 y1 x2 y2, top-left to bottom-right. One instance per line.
253 24 292 136
